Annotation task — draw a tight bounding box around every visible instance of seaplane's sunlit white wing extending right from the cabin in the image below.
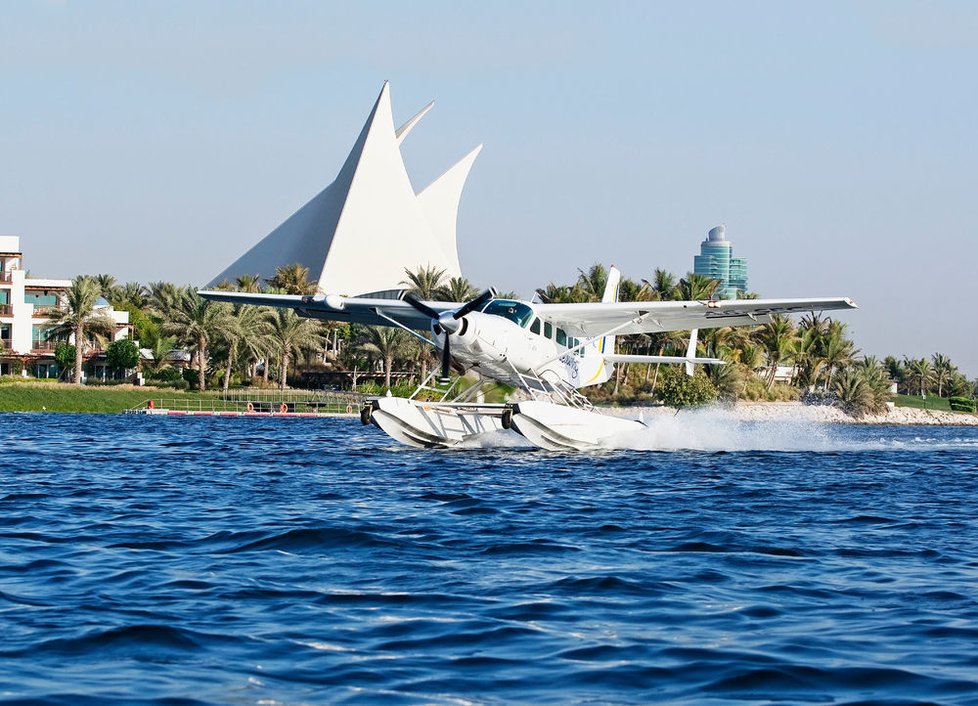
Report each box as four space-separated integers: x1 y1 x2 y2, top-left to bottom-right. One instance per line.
533 297 858 338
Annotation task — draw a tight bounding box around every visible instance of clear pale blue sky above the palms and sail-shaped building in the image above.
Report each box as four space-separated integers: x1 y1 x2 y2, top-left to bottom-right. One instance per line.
0 0 978 376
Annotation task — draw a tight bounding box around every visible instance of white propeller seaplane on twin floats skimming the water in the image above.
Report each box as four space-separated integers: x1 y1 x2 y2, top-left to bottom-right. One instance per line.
200 267 855 451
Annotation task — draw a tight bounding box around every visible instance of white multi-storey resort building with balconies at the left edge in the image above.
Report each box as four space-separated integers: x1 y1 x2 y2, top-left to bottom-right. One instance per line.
0 235 132 378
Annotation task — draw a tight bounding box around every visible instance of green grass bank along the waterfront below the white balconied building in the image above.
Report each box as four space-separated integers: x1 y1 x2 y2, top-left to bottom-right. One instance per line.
0 382 210 413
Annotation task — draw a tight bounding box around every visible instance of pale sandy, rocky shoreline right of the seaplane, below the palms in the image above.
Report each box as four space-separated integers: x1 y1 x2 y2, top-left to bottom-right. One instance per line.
620 402 978 426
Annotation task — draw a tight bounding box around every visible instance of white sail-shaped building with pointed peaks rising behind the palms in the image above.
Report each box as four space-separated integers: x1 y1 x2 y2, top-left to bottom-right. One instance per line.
211 82 482 295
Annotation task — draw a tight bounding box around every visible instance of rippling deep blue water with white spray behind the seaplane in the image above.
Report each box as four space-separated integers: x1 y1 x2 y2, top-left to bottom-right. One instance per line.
0 414 978 704
